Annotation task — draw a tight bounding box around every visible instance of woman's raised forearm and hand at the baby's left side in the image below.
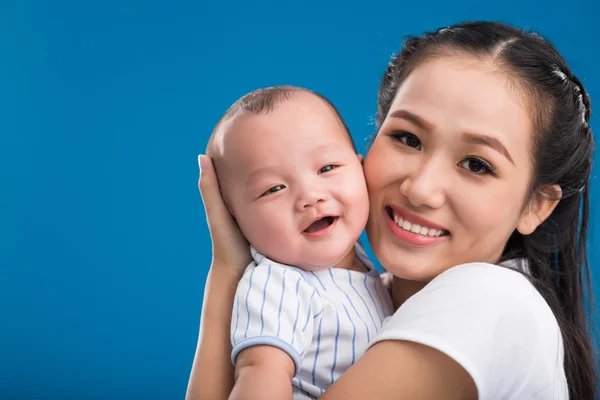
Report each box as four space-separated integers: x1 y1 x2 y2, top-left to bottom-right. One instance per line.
186 156 251 400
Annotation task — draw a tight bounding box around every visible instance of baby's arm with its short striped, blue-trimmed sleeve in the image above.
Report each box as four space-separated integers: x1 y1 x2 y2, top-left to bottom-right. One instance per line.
230 262 322 399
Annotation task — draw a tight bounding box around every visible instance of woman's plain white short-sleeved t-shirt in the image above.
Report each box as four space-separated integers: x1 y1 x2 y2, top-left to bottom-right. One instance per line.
370 263 568 400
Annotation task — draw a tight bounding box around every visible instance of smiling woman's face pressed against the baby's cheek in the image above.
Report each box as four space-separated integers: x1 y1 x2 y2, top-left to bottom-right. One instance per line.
364 57 537 282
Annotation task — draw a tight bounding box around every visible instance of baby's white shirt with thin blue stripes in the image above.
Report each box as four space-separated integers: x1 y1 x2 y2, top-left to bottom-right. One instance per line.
231 243 393 400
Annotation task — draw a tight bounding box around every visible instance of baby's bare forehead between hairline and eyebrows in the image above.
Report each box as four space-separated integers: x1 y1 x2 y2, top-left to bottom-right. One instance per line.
213 92 356 175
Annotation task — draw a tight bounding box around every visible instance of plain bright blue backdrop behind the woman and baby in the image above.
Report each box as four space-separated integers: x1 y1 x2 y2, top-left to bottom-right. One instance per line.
0 0 600 399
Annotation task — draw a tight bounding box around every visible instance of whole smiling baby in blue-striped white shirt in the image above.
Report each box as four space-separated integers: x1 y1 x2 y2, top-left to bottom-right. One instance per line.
207 86 392 399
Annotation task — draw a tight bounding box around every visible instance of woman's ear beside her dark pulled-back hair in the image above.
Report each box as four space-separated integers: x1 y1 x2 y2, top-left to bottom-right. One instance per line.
517 185 562 235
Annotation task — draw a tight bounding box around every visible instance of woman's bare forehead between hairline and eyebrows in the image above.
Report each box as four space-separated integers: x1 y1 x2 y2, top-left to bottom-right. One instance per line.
386 57 533 161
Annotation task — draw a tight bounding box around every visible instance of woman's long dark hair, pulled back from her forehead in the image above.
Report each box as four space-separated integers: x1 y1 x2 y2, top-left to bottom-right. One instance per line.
376 22 598 400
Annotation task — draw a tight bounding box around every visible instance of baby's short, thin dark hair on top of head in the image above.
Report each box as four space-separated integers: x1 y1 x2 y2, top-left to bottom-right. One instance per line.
206 85 356 155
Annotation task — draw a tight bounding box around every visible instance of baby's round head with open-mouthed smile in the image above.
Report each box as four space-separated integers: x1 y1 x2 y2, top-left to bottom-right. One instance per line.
207 86 369 270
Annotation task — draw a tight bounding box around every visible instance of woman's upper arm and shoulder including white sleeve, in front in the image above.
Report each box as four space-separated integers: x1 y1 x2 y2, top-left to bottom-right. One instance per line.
322 263 566 400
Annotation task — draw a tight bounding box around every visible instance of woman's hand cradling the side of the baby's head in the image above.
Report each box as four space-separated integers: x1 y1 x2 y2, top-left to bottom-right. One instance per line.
198 155 251 275
